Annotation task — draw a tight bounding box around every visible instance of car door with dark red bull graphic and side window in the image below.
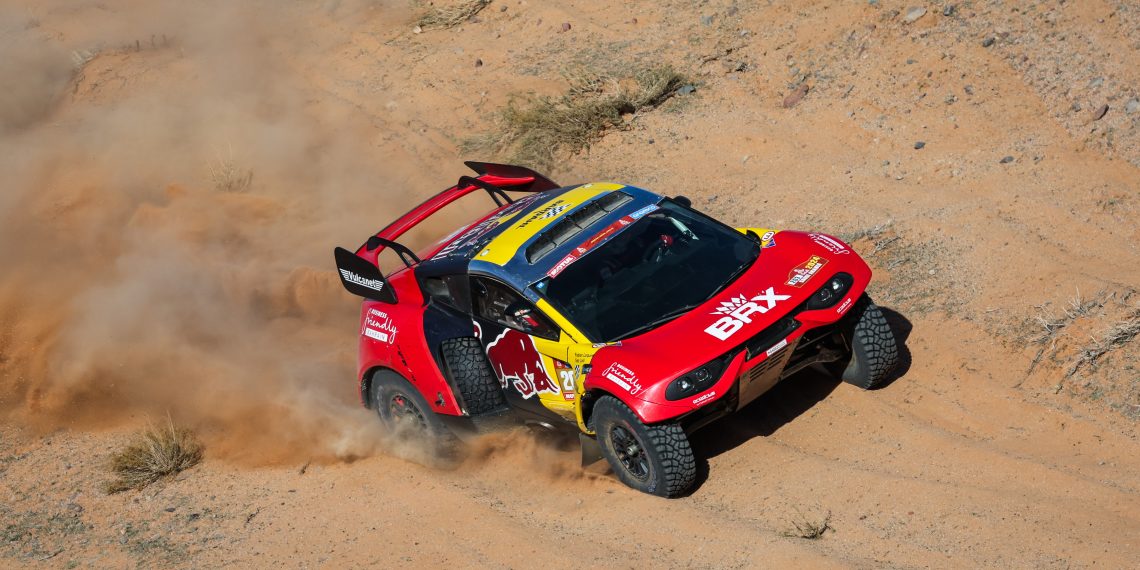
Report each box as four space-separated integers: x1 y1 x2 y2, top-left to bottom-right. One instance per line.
471 277 577 422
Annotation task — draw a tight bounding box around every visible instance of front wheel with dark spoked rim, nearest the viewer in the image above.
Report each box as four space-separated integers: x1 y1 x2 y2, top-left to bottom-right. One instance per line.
591 396 697 497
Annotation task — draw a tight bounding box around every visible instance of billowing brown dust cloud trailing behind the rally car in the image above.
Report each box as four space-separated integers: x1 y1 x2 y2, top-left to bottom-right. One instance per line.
0 0 421 464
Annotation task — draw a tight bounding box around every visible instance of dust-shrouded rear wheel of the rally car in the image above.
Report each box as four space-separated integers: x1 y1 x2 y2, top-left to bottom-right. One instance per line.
371 371 455 454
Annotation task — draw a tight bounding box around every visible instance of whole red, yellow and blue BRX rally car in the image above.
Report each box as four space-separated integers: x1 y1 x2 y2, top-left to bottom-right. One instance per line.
335 162 898 497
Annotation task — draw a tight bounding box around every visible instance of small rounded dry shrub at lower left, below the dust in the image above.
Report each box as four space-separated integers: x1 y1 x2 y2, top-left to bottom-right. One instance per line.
104 418 202 494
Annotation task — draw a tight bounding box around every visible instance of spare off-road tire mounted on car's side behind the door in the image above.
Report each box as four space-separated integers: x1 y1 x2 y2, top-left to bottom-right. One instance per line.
440 336 506 416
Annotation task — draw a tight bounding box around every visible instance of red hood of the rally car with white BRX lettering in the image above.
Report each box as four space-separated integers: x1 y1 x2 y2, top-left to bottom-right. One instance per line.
586 231 871 405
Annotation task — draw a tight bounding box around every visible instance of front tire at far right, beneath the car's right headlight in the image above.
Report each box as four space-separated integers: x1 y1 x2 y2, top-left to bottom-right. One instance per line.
841 295 898 390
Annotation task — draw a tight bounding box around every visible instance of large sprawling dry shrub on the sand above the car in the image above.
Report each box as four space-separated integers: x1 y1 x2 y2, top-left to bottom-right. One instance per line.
463 65 687 169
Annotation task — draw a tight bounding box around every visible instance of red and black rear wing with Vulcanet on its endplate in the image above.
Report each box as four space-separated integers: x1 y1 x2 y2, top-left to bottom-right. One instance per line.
333 161 560 303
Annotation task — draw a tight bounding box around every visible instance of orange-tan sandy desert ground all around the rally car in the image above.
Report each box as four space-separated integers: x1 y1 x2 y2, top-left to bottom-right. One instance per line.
0 0 1140 569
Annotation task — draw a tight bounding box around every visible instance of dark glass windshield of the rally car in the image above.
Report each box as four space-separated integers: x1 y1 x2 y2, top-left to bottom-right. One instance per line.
535 200 760 342
